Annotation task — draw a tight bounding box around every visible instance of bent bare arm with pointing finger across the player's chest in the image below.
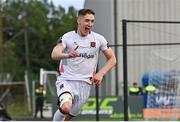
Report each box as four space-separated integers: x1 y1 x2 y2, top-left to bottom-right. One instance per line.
51 44 78 60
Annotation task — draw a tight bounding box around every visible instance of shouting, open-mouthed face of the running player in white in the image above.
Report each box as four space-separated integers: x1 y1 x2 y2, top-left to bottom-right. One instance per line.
77 14 95 36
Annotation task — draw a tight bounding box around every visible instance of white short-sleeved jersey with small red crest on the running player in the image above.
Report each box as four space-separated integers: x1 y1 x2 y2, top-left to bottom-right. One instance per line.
59 31 108 84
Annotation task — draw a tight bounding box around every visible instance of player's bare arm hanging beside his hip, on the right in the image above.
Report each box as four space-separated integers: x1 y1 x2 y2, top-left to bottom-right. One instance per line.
93 48 116 85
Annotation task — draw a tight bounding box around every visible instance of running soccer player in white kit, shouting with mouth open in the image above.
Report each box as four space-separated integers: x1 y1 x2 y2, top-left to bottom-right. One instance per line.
51 9 116 121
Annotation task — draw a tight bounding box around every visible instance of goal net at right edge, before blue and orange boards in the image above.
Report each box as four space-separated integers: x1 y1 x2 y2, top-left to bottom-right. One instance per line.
144 47 180 120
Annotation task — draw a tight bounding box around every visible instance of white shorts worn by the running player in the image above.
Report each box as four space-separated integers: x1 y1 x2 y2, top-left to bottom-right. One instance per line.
56 77 92 116
